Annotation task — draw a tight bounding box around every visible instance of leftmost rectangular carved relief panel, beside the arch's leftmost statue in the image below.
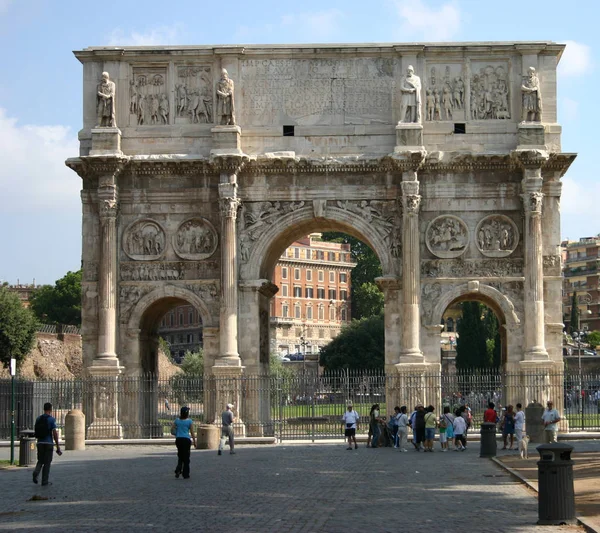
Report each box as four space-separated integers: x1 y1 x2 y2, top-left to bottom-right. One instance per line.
129 67 171 126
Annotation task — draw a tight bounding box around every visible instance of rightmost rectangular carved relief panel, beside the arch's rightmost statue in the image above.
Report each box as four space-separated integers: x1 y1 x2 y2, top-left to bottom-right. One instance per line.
470 62 511 120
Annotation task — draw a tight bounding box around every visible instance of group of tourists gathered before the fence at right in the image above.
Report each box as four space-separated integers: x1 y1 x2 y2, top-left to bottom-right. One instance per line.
342 401 561 452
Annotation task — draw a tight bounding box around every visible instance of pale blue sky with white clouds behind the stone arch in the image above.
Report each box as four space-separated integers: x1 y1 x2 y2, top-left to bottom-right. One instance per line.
0 0 600 284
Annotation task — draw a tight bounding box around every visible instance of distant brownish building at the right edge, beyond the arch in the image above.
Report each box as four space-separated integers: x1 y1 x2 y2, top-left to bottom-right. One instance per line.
561 236 600 331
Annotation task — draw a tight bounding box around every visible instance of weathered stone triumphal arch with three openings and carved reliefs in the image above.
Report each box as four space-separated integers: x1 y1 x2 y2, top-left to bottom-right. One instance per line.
67 42 575 435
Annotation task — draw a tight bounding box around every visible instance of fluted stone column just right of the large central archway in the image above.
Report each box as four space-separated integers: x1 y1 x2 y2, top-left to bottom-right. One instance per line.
400 177 423 363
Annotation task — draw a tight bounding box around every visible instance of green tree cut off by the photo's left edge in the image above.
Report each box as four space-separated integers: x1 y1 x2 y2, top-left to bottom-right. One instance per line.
0 287 37 367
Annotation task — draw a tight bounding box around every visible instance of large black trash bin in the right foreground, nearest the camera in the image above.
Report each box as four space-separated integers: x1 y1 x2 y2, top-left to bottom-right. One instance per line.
536 443 577 525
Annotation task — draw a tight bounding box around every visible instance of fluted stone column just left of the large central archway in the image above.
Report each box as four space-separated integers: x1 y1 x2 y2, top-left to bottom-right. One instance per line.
215 183 241 366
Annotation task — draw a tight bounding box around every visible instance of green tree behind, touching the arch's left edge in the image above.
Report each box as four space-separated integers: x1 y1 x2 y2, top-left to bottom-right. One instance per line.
29 270 81 326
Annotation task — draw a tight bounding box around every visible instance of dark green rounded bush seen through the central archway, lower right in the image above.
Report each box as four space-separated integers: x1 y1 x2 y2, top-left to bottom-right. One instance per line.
319 315 385 370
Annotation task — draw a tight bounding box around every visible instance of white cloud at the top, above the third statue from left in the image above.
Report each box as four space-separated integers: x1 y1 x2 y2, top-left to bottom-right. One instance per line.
394 0 461 42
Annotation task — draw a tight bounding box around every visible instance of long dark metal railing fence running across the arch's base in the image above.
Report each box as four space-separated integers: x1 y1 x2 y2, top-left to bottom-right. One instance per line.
0 370 600 441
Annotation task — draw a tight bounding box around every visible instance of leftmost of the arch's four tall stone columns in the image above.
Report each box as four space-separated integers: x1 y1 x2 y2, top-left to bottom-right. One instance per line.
96 185 118 366
